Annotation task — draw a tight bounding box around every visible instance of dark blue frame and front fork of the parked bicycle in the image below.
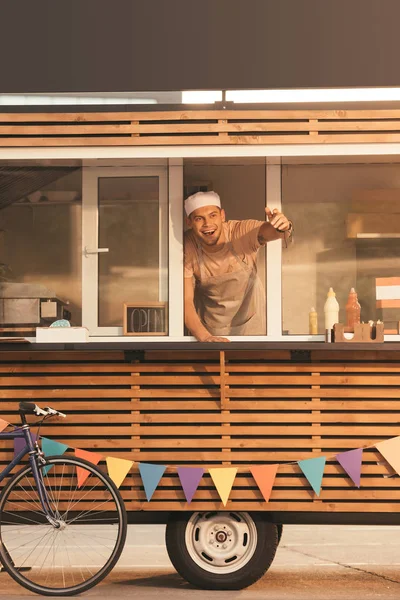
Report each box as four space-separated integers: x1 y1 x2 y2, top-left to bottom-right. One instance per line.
0 424 57 526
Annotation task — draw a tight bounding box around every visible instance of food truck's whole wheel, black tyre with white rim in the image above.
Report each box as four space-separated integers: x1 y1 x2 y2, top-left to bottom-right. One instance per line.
166 512 278 590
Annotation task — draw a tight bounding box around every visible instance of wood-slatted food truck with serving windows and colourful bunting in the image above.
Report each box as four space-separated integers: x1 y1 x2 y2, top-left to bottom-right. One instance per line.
0 105 400 589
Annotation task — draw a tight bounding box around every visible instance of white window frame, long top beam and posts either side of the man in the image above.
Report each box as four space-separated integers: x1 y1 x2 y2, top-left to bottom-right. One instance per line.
0 143 400 342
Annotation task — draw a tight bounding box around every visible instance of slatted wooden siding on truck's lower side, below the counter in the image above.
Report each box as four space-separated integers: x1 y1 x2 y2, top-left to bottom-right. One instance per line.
0 350 400 522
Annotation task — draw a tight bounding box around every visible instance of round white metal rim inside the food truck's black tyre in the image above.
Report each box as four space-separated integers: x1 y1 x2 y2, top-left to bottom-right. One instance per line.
185 512 257 575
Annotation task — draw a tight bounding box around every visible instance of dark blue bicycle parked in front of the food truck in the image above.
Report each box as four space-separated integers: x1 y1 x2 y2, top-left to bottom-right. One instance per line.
0 402 127 596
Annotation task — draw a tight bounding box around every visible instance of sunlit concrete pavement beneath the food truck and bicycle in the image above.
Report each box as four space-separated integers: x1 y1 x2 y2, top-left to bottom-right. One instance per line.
0 525 400 600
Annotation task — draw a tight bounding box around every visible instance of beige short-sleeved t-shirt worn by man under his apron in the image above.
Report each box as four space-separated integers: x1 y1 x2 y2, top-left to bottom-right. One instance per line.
184 219 264 280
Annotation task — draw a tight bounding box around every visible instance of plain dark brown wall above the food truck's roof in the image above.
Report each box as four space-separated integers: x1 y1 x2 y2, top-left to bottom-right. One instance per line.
0 0 400 93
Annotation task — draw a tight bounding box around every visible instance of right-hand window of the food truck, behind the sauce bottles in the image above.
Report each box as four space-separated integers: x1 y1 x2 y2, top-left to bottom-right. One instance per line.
281 157 400 335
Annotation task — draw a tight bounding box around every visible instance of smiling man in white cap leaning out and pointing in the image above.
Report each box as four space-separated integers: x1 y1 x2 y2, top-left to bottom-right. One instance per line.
184 192 293 342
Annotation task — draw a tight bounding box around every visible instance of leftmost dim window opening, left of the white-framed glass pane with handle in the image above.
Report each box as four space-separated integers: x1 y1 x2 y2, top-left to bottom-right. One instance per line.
0 161 82 337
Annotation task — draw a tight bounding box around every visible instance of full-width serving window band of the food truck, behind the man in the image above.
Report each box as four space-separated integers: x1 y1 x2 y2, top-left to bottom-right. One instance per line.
0 154 400 341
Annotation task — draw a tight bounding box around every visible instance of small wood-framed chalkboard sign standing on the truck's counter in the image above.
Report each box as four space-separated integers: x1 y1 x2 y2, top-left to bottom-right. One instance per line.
124 302 167 336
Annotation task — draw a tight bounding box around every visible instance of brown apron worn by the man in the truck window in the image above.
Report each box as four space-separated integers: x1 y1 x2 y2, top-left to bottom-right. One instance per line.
195 234 266 335
